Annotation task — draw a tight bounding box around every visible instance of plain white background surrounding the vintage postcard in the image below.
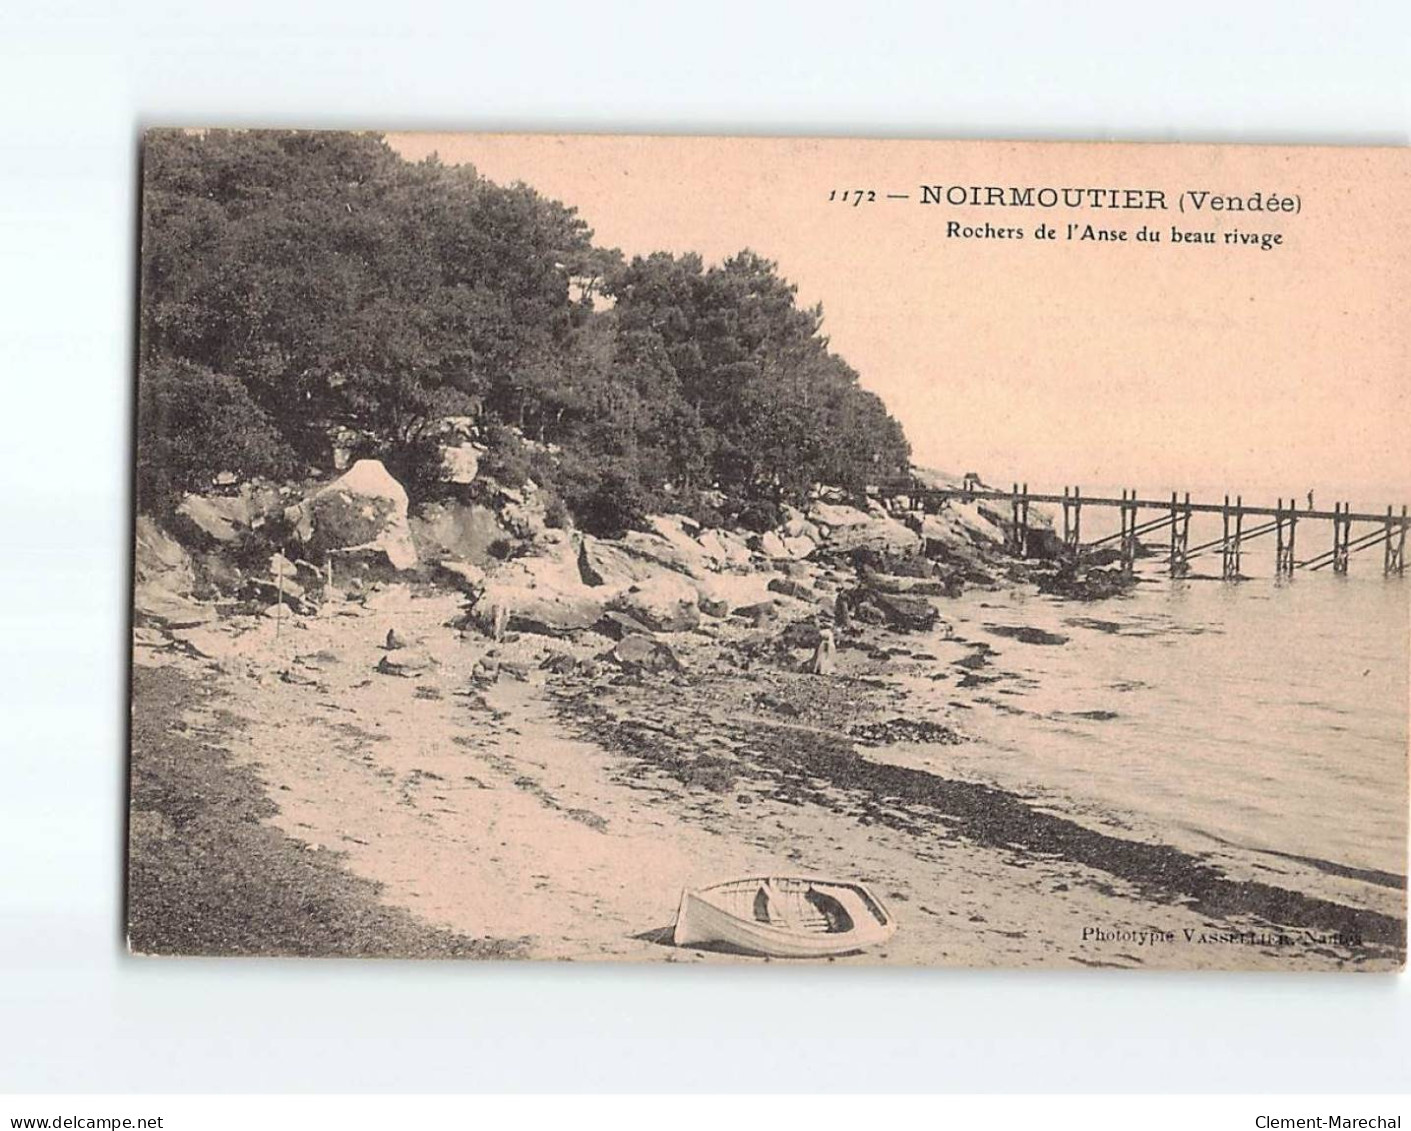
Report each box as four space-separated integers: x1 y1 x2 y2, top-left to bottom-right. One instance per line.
0 0 1411 1092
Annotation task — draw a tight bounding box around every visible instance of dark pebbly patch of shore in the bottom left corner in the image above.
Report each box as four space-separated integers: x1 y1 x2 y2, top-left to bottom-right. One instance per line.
126 666 519 959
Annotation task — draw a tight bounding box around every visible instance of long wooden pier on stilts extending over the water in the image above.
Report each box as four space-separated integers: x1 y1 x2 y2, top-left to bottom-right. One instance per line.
886 482 1411 580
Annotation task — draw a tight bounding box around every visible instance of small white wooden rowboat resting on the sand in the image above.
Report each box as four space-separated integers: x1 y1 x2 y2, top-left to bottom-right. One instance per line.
672 876 896 958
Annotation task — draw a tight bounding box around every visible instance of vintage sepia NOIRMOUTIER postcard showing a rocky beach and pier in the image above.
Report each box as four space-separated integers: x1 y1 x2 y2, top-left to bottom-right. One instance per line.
127 130 1411 972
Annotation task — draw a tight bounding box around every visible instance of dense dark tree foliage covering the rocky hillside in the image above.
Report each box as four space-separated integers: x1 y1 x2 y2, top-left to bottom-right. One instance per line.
138 131 909 529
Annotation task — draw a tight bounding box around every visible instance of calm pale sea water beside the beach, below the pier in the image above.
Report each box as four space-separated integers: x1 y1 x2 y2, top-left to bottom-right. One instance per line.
913 549 1411 914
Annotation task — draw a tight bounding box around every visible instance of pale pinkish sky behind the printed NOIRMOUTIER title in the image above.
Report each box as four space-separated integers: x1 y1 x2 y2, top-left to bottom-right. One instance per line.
389 134 1411 503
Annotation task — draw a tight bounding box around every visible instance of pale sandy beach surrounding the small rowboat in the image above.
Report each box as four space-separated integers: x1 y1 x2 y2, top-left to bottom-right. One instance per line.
126 533 1405 970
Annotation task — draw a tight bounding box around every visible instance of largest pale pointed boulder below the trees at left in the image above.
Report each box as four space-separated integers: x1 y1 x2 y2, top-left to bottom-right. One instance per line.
289 460 416 570
